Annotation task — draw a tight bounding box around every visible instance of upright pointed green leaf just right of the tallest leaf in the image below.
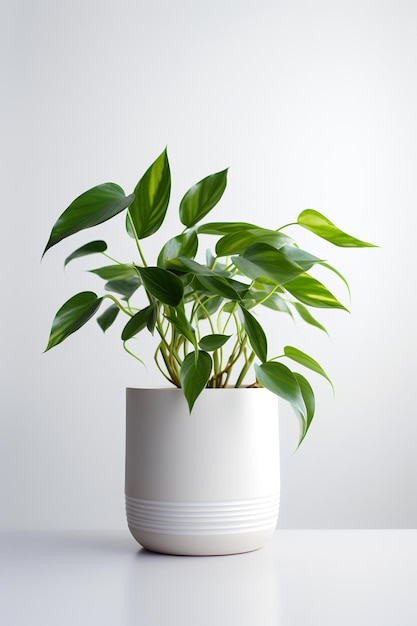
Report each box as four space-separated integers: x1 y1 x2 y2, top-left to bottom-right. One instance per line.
180 169 227 228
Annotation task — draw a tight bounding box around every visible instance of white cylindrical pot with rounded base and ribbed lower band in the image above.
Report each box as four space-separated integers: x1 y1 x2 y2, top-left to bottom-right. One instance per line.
126 388 279 555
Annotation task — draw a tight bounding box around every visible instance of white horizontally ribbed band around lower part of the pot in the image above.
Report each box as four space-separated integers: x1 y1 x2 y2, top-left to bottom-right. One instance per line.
126 494 279 535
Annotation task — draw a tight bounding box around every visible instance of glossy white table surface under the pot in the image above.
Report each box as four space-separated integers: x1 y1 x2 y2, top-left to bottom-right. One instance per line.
0 530 417 626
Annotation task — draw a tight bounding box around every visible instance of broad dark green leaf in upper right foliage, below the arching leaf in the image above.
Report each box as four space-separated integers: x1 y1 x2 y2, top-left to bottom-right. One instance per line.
232 243 304 284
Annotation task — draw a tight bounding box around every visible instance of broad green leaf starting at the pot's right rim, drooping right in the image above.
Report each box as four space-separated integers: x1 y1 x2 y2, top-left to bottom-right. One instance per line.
255 361 307 416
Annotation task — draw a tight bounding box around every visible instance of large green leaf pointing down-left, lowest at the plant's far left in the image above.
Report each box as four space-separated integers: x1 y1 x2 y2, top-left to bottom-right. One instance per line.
45 291 103 352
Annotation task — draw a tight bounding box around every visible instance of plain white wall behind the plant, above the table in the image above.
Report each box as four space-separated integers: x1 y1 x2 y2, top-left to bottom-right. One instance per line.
0 0 417 529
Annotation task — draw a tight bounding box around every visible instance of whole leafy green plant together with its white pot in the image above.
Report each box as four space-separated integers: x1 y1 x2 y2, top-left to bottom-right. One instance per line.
44 150 372 554
